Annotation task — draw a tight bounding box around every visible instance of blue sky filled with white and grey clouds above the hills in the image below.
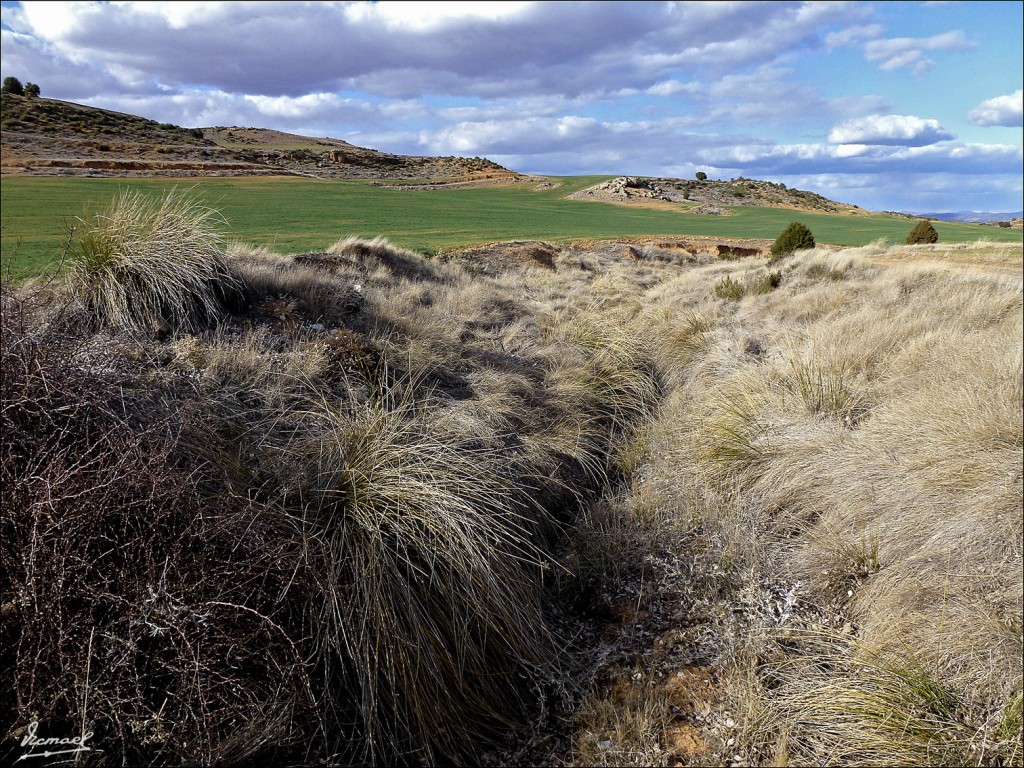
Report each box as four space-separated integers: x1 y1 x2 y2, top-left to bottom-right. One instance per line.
0 1 1024 212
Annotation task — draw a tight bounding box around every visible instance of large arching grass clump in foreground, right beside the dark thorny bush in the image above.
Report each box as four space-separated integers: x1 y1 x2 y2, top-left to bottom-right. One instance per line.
264 393 551 762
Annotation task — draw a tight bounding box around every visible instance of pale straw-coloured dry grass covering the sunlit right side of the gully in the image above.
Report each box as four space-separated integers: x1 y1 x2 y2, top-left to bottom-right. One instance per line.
573 244 1024 765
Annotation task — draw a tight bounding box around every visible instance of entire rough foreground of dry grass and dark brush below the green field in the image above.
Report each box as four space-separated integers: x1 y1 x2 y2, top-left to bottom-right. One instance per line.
0 197 1024 765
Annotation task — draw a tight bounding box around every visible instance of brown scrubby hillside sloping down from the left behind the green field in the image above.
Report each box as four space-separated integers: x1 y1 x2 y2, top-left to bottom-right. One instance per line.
0 93 521 182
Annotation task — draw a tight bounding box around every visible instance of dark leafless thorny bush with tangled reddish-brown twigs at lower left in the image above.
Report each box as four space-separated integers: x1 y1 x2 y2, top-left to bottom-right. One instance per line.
0 291 314 765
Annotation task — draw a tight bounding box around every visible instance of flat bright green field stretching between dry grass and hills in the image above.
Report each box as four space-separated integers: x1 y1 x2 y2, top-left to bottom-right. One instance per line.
0 176 1021 276
